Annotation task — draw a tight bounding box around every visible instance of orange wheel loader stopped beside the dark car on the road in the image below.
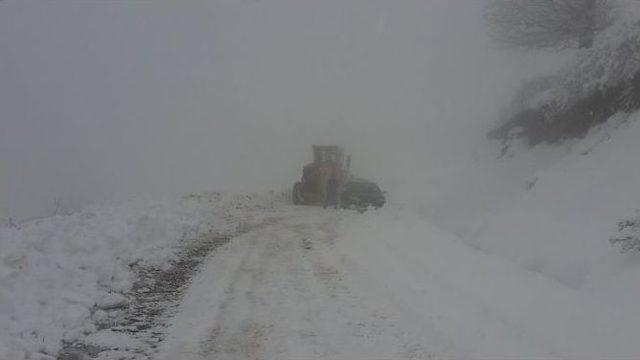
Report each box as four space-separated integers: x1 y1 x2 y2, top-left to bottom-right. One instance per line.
292 145 351 205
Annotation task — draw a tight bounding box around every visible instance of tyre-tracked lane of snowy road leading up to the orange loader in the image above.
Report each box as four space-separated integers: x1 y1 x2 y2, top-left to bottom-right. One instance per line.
159 209 458 359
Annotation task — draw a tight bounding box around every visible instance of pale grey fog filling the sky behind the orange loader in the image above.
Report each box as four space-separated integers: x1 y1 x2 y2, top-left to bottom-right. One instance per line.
0 0 556 219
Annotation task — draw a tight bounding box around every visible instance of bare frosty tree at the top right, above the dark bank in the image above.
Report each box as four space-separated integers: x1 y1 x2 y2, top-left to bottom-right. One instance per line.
485 0 614 49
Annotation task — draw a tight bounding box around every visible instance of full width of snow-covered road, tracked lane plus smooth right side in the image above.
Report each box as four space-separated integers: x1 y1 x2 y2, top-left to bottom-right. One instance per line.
154 207 640 360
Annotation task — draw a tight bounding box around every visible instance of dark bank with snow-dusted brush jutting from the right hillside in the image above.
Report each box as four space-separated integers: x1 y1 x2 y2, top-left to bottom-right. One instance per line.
488 22 640 146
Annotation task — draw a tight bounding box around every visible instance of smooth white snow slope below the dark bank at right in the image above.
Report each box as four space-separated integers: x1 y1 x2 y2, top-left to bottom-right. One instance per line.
425 113 640 303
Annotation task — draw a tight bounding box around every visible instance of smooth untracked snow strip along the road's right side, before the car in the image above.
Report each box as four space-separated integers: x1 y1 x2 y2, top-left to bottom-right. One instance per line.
336 208 640 359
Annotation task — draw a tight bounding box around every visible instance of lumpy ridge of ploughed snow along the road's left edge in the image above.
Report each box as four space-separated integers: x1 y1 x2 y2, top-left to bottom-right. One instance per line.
0 192 282 360
